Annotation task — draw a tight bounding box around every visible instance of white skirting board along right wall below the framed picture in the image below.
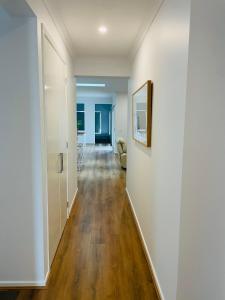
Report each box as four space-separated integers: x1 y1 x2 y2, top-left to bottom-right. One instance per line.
126 188 165 300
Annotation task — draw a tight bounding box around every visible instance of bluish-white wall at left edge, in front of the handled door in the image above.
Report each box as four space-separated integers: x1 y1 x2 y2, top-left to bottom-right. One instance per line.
0 11 45 286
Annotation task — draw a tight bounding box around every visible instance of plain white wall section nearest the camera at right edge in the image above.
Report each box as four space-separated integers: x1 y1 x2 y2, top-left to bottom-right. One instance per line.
177 0 225 300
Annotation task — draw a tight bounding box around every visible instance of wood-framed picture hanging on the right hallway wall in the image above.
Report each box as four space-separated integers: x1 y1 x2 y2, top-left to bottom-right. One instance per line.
132 80 153 147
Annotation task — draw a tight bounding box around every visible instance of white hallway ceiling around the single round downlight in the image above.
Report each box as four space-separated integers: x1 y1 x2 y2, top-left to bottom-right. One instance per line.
43 0 161 56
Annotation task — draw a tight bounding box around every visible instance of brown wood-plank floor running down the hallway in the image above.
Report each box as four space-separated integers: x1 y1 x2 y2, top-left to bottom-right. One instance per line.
13 146 157 300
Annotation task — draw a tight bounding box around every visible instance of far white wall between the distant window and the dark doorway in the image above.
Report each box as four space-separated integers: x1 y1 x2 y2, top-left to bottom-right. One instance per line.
77 96 112 144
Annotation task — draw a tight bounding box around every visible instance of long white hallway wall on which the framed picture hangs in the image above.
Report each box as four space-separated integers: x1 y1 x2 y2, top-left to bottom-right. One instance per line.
127 0 190 300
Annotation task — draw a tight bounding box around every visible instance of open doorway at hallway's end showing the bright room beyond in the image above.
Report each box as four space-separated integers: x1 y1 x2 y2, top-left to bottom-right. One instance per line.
76 77 128 171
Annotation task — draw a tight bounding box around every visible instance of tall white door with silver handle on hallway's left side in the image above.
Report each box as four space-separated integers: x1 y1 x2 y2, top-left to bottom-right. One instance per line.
43 34 67 264
